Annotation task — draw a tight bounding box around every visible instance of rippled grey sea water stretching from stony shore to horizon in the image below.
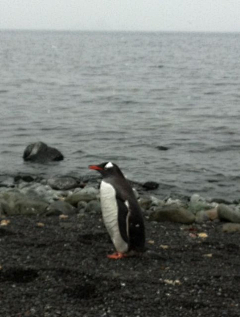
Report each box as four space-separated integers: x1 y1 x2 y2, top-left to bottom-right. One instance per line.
0 31 240 200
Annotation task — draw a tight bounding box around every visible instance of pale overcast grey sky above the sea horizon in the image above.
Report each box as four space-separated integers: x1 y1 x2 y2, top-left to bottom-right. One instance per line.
0 0 240 32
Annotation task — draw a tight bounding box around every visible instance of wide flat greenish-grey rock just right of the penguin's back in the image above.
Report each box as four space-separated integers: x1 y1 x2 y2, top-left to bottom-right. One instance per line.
149 204 195 224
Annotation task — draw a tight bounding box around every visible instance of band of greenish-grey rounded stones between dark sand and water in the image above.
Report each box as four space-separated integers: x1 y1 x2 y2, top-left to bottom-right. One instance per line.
0 174 240 224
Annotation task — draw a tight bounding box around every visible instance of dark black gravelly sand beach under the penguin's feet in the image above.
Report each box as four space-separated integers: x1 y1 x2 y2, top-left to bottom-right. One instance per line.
0 215 240 317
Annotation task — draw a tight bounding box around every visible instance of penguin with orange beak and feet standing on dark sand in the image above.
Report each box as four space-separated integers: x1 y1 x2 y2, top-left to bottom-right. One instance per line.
89 162 145 259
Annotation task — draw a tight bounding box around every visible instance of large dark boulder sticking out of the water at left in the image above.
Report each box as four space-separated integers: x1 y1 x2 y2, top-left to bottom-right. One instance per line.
23 142 64 163
